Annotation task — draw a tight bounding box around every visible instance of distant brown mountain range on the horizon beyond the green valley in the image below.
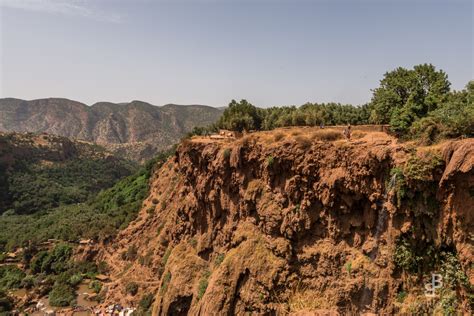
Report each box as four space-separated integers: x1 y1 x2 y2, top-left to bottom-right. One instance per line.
0 98 223 161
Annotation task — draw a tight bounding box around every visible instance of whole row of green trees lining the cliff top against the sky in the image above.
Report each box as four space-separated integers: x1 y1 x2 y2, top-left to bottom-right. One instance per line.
191 64 474 143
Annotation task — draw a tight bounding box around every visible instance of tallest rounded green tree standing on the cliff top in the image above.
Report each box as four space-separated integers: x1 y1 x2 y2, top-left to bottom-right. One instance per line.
370 64 451 135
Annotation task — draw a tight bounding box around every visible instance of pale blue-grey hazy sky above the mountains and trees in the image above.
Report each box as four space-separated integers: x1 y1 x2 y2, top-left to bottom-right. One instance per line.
0 0 474 107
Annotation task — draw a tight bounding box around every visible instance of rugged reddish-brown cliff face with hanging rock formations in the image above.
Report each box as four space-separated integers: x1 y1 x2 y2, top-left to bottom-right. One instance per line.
99 129 474 315
